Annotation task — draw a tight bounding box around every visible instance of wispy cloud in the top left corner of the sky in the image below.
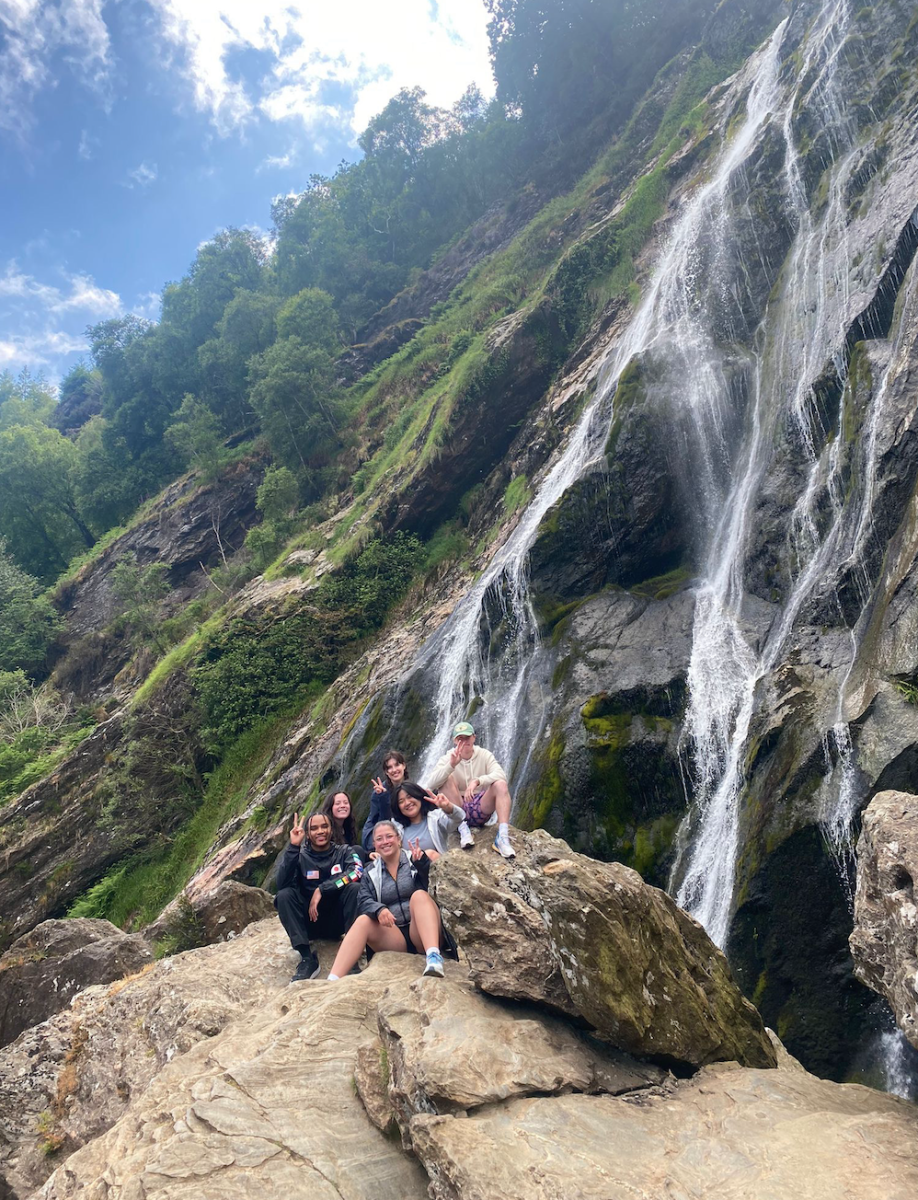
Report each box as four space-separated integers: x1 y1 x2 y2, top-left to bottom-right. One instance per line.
0 0 110 138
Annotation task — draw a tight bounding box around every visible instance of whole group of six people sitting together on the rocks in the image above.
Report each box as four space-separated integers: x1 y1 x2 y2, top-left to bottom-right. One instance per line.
275 721 514 982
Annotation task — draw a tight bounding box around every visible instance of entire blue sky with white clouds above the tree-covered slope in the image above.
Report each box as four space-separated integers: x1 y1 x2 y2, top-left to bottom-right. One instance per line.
0 0 491 380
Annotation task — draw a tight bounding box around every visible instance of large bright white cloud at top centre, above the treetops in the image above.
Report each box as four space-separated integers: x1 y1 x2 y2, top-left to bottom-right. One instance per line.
149 0 491 133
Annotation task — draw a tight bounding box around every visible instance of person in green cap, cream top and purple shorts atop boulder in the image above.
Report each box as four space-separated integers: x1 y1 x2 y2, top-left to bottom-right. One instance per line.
427 721 516 858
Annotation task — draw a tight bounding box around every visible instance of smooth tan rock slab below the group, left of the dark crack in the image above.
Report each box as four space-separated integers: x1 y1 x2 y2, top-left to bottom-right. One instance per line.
38 955 428 1200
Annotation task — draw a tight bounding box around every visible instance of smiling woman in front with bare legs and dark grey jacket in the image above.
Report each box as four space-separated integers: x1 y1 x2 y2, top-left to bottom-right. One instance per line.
329 821 443 979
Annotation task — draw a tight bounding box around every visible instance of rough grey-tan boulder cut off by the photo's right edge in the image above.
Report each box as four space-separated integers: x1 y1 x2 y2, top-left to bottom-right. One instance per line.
850 792 918 1046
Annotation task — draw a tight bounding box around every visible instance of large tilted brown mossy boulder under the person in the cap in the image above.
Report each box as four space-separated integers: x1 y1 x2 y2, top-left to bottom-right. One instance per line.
432 830 775 1067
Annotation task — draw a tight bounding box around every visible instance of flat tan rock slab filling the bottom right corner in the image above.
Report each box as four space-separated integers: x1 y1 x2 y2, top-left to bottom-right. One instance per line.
410 1066 918 1200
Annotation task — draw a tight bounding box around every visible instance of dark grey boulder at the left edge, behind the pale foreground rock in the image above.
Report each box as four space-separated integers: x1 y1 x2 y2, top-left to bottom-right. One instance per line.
0 918 152 1046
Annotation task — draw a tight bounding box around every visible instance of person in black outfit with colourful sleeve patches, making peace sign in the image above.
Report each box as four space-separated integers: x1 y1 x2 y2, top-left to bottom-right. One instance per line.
274 812 364 983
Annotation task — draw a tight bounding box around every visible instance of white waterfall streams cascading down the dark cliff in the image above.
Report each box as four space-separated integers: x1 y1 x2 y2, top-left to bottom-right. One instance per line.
403 0 912 969
